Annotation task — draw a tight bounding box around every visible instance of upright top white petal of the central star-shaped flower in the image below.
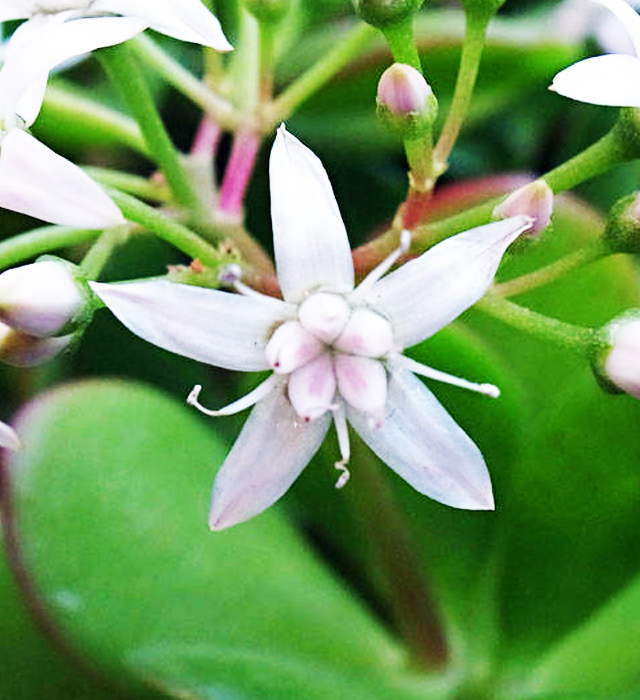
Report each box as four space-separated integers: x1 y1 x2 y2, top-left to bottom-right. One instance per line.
269 125 353 302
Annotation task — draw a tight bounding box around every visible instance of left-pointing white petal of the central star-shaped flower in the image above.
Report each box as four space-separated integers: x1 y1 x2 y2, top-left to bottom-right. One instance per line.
91 280 291 372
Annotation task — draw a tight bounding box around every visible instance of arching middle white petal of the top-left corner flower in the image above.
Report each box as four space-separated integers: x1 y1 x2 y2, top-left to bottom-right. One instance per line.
0 13 146 125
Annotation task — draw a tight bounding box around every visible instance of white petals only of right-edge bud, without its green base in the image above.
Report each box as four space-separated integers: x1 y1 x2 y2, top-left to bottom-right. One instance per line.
603 313 640 399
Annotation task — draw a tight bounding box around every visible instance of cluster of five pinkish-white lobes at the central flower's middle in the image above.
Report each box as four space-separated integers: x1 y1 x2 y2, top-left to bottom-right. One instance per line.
265 292 394 423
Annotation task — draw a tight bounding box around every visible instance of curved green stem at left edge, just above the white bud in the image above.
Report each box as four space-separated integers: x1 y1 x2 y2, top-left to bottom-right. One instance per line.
0 226 101 270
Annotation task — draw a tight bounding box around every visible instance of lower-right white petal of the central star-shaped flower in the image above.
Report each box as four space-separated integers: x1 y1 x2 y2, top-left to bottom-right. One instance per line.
347 369 493 510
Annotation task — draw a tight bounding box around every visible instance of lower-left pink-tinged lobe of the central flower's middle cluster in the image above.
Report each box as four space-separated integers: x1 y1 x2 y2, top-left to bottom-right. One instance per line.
288 352 336 421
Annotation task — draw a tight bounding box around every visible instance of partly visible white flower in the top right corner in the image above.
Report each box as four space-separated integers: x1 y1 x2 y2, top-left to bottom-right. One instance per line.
550 0 640 107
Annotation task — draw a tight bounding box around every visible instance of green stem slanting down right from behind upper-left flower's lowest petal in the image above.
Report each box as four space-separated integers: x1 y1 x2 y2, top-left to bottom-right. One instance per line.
106 188 220 265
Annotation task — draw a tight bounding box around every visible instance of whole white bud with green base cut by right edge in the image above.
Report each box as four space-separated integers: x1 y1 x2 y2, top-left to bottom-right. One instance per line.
594 310 640 399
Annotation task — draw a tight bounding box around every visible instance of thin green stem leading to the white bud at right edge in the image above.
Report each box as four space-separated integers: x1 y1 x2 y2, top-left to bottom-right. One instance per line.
476 292 595 355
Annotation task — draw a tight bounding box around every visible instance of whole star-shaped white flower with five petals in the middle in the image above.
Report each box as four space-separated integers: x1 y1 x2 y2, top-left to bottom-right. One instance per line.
91 126 531 529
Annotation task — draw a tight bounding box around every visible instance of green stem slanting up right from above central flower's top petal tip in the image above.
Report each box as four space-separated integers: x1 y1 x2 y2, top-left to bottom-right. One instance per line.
265 24 377 131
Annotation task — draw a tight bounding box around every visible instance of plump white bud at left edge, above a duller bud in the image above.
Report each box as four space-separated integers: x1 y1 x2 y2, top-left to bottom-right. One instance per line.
0 260 86 336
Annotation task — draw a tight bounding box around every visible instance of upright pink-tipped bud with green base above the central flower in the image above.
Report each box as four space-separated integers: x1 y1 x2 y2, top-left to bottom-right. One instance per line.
376 63 438 139
